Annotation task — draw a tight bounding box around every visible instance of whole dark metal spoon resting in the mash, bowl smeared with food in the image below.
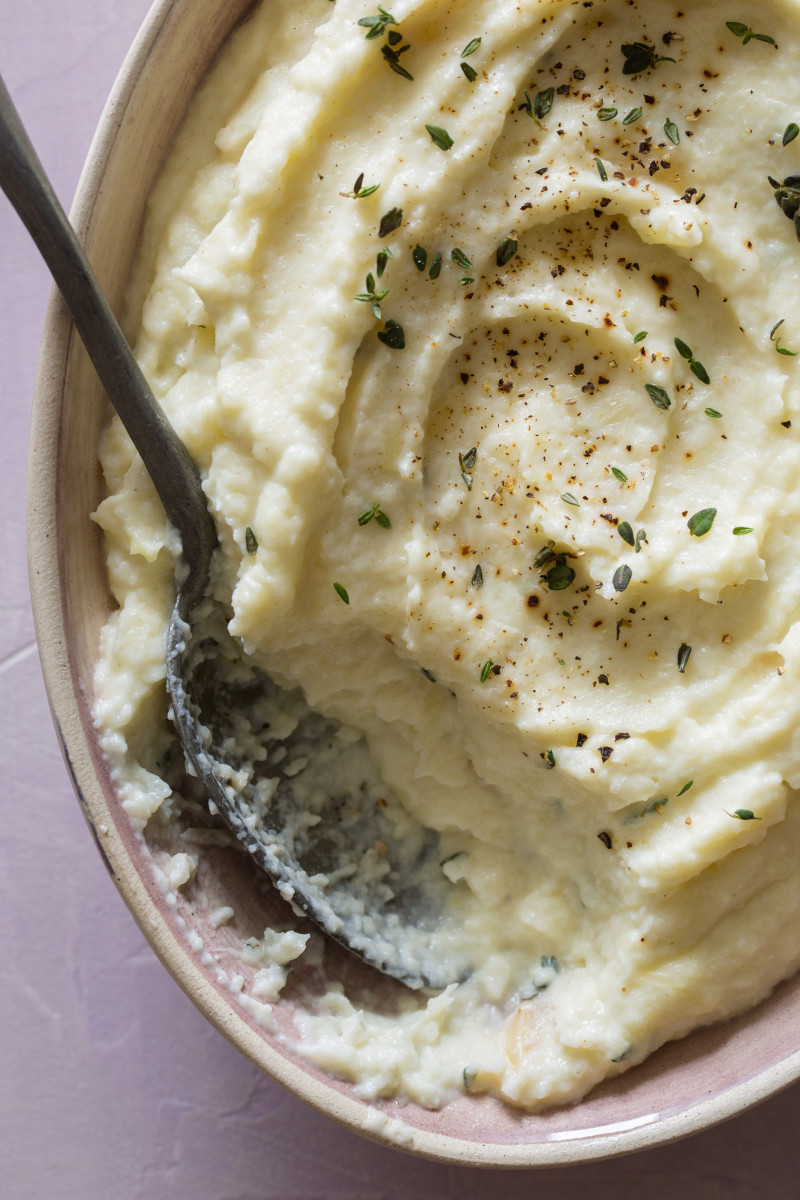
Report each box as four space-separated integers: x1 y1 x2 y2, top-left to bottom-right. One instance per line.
0 72 469 988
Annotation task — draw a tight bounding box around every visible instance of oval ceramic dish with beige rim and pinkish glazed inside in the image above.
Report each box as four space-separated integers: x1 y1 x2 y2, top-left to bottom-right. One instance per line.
29 0 800 1166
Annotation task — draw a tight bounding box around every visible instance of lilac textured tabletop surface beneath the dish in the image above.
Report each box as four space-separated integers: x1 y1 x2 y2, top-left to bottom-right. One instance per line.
0 0 800 1200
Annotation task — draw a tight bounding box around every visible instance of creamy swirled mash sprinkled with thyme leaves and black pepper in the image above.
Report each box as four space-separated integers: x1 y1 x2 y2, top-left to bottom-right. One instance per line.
97 0 800 1108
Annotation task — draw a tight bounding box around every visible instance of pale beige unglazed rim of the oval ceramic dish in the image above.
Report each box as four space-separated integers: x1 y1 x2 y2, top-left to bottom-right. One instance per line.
21 0 800 1169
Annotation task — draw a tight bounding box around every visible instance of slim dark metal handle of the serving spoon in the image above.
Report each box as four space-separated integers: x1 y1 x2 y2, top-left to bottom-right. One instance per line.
0 68 217 600
